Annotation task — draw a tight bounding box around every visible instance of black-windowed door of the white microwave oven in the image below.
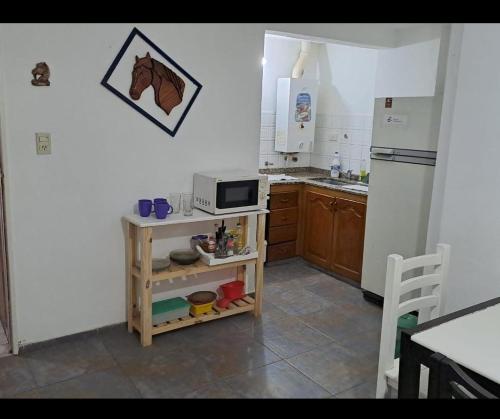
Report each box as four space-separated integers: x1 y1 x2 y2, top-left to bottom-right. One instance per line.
216 180 259 209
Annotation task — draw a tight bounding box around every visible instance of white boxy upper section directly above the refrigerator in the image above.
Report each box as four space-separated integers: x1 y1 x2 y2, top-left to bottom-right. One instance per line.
375 39 440 98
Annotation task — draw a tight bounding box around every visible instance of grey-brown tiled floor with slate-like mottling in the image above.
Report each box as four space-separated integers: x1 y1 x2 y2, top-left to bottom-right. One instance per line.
0 259 382 398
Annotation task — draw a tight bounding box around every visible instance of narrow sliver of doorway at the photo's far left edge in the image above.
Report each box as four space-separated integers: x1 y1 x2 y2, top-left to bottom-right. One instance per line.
0 130 11 357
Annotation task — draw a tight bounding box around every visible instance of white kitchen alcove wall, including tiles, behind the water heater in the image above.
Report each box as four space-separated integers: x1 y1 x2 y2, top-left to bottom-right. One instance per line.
259 36 377 173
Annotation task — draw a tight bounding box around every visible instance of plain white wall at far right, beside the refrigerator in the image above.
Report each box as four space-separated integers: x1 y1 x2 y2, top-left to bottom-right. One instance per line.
431 24 500 312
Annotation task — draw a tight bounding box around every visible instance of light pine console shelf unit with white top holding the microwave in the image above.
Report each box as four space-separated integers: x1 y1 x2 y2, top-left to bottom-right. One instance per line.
124 209 269 346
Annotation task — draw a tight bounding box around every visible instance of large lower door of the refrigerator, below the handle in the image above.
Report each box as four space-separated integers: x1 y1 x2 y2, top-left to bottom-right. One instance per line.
361 159 434 297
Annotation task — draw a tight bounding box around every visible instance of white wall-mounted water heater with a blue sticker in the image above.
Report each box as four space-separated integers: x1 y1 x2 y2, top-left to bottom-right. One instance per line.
274 78 318 153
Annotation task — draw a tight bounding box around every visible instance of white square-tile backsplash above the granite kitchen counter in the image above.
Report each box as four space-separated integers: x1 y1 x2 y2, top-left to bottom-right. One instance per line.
259 112 373 174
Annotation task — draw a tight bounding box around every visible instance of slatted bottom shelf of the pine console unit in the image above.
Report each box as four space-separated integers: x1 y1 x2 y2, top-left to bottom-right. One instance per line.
133 296 255 335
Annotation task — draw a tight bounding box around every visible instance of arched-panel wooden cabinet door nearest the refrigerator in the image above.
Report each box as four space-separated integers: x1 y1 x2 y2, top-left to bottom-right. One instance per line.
330 198 366 281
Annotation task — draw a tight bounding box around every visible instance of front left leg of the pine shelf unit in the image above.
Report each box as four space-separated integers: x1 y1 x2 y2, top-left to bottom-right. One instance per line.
140 227 153 346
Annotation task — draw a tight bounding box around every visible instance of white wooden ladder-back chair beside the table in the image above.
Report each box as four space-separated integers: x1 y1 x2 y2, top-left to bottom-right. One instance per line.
376 244 450 398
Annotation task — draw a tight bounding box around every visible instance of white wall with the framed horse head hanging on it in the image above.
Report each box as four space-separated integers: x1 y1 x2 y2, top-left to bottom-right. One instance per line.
0 24 408 345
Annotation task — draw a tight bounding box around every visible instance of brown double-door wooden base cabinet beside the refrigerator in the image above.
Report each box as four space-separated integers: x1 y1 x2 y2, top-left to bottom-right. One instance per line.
303 185 366 281
